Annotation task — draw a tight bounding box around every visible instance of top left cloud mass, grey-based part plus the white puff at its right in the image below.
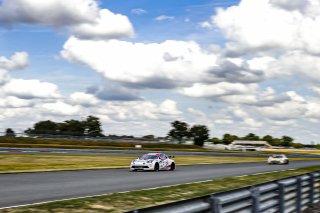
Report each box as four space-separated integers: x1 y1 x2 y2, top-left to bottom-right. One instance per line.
0 0 134 40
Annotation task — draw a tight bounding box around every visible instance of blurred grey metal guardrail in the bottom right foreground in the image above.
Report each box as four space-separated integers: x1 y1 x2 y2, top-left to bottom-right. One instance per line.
131 171 320 213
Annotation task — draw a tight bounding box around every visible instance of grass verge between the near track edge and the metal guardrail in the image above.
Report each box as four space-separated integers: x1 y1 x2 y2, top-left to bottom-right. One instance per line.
0 166 320 213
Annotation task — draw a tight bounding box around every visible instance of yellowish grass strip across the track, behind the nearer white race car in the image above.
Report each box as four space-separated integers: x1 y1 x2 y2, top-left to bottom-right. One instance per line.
0 154 276 173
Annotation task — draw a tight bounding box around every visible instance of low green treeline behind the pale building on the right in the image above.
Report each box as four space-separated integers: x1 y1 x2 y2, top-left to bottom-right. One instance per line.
210 133 304 148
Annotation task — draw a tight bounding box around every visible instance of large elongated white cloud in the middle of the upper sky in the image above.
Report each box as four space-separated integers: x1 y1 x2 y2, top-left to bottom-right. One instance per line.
61 37 217 88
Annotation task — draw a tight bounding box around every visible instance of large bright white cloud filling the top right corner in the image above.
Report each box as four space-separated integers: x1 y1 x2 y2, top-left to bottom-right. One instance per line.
211 0 320 54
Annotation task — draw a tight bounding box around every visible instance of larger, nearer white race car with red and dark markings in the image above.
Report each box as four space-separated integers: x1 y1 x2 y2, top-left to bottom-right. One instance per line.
130 153 176 171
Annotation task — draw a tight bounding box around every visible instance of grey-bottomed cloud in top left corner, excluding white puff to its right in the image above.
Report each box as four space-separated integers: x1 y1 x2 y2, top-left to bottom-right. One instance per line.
0 0 98 27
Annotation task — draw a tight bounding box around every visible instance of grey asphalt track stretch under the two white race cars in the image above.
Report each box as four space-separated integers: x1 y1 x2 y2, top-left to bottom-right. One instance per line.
0 161 320 207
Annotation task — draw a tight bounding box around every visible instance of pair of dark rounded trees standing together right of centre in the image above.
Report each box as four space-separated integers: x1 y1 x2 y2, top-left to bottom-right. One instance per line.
168 121 209 146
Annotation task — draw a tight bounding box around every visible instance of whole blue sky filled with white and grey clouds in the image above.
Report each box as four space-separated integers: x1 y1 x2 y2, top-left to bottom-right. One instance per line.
0 0 320 143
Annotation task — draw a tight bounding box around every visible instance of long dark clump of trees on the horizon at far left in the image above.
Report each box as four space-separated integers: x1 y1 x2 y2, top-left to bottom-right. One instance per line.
25 115 103 137
